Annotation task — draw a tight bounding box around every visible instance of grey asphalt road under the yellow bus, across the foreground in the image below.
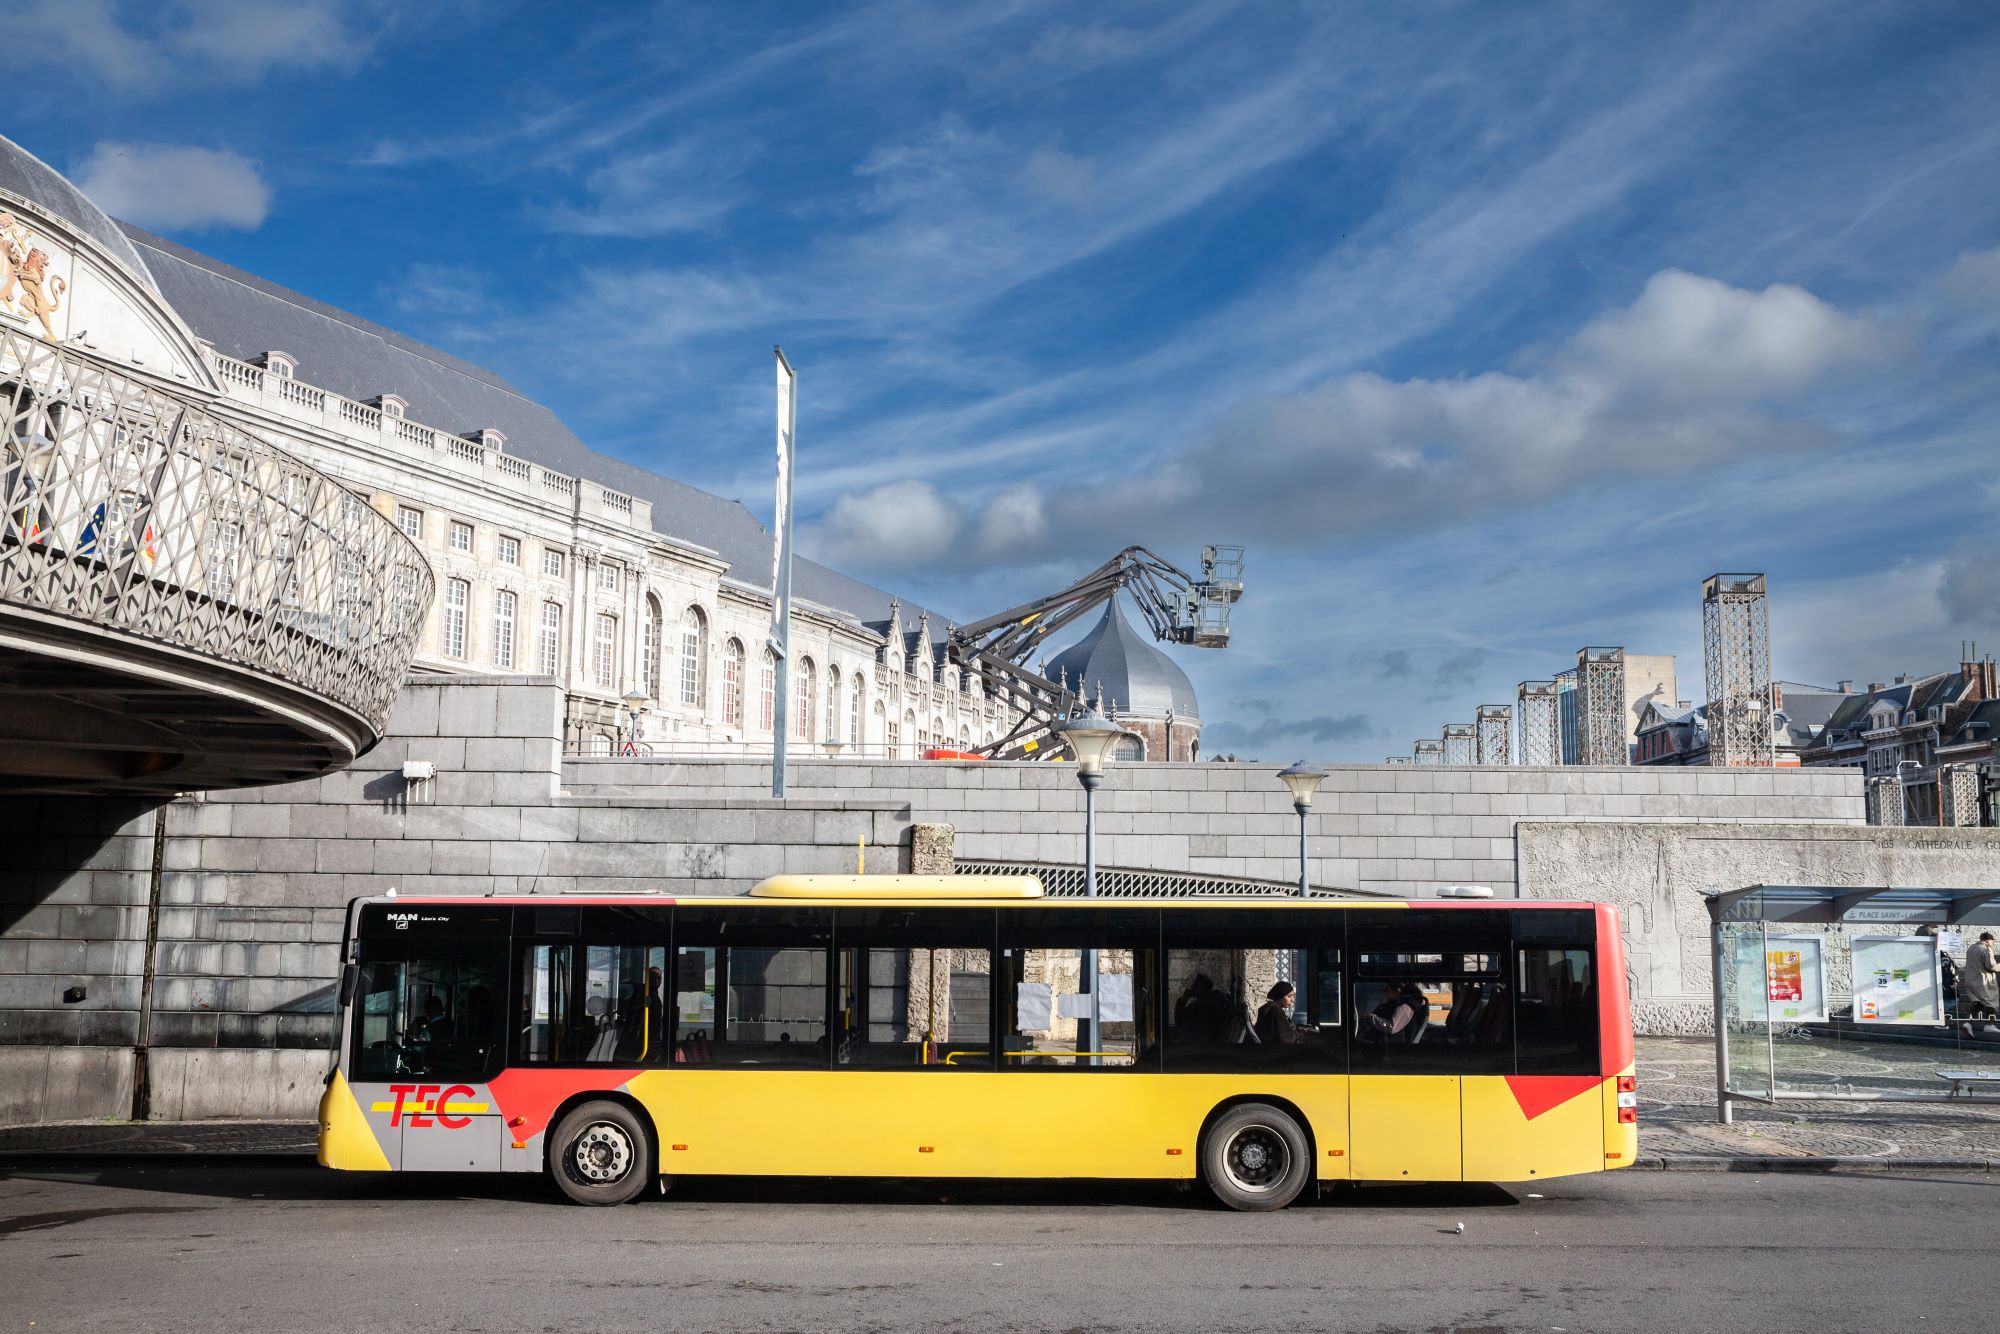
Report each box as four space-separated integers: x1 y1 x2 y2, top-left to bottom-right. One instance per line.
0 1162 2000 1334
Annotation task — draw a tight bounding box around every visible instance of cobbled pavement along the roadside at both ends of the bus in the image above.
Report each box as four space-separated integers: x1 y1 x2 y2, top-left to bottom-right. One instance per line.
0 1038 2000 1170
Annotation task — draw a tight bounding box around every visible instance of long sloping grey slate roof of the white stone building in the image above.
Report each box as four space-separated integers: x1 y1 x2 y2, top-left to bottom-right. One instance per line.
117 224 946 638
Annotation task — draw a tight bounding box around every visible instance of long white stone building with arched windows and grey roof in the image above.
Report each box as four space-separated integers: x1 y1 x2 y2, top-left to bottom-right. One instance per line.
0 140 1032 756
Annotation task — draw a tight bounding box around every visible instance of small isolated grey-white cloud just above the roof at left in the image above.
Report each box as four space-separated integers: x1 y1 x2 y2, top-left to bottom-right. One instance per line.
70 140 270 230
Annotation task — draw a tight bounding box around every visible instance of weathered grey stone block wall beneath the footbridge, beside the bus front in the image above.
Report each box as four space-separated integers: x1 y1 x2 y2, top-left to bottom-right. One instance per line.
0 676 916 1124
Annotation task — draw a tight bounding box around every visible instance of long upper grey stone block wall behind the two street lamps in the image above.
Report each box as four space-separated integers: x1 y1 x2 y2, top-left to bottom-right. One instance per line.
564 758 1864 896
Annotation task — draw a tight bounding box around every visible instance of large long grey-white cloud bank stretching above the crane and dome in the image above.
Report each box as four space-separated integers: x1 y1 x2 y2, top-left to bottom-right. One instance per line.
812 270 1894 568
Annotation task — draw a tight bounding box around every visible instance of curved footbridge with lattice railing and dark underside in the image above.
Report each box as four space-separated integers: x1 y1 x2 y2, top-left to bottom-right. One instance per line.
0 328 432 794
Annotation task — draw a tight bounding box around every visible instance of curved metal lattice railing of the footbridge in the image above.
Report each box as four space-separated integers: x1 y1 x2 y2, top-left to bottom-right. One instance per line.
0 330 432 730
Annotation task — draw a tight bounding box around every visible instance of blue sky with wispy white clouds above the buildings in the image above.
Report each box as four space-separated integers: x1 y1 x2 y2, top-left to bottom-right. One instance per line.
6 0 2000 760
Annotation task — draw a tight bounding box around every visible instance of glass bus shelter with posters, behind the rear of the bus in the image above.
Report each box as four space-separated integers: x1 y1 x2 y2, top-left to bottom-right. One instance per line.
1706 884 2000 1124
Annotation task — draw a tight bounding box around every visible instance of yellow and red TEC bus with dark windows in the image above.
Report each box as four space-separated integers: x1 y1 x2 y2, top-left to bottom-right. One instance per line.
320 876 1638 1210
